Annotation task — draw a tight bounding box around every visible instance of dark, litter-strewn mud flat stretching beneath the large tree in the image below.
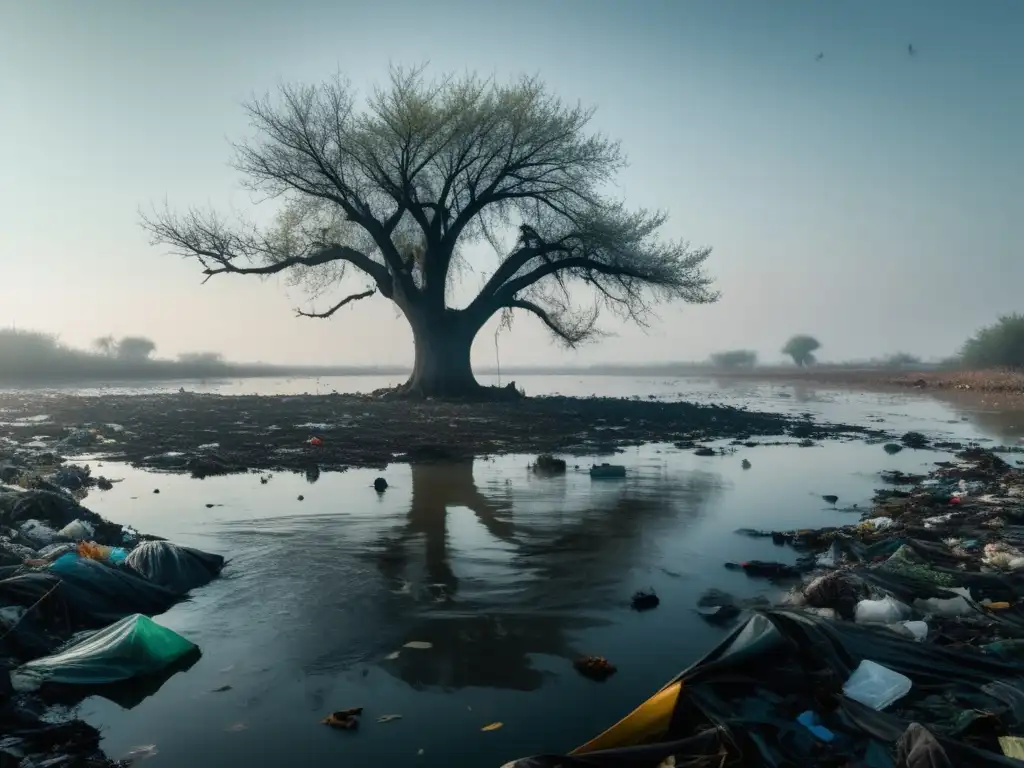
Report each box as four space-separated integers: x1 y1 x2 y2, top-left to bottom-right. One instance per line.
0 392 883 476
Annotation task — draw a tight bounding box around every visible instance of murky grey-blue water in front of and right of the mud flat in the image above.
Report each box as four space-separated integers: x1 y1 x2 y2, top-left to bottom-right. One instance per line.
39 378 1020 768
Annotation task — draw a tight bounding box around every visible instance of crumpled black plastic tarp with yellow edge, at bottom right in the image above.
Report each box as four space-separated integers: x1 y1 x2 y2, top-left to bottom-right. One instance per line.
501 609 1024 768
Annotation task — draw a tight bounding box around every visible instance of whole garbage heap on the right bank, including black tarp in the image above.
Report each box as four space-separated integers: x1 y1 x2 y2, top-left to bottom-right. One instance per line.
510 449 1024 768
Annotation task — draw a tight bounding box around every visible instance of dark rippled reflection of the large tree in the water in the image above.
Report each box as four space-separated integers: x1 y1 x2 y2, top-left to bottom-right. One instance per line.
377 462 720 690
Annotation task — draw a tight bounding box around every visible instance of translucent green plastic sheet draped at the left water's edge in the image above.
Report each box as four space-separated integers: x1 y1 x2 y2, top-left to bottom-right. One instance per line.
10 613 196 691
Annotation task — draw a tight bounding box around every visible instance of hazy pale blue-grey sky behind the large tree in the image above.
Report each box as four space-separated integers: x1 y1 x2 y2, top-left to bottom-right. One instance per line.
0 0 1024 365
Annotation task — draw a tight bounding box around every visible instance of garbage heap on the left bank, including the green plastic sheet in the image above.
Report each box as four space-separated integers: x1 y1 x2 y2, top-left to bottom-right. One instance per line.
0 486 224 768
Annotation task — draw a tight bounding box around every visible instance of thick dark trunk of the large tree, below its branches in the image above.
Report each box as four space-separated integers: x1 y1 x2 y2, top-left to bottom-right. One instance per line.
403 309 483 397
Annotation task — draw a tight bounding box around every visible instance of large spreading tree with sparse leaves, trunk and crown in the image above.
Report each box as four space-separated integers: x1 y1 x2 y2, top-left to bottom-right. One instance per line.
143 68 718 396
